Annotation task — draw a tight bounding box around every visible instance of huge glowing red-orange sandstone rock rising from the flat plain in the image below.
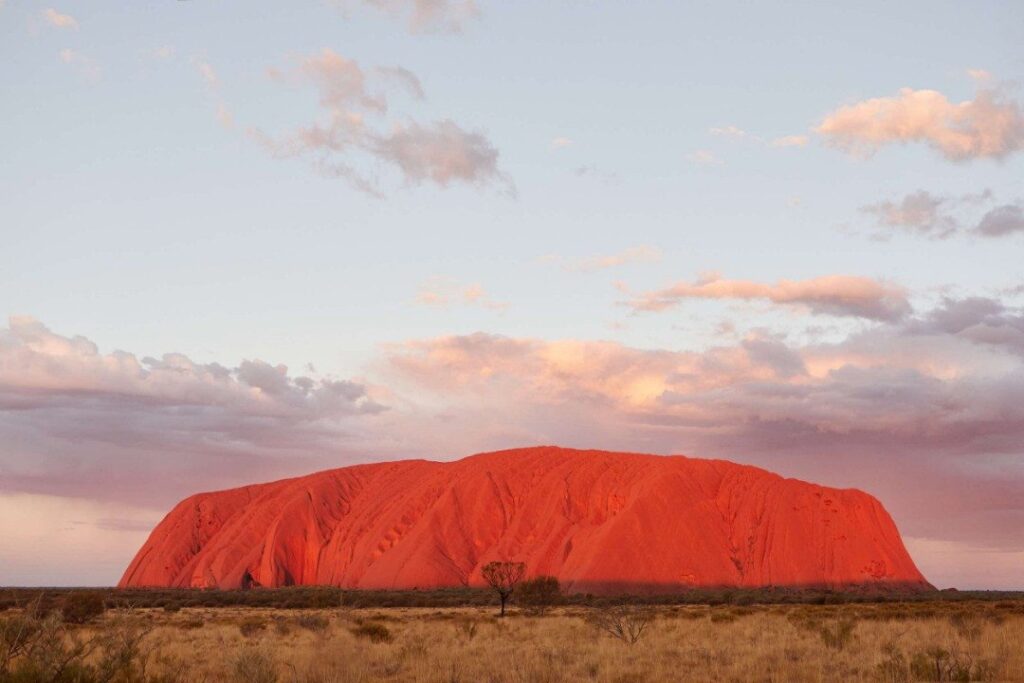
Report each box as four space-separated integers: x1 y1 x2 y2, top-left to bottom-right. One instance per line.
120 447 929 593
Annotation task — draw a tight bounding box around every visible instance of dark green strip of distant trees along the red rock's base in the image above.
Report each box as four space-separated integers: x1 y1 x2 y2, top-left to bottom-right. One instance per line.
0 587 1024 611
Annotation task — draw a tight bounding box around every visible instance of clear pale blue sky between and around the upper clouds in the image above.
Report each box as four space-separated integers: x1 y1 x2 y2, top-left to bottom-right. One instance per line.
0 0 1024 374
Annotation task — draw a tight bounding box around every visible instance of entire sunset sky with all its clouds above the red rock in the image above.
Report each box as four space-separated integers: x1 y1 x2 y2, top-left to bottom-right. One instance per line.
0 0 1024 589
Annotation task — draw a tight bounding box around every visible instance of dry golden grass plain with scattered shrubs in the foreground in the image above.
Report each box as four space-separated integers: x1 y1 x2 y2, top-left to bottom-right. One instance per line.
0 585 1024 683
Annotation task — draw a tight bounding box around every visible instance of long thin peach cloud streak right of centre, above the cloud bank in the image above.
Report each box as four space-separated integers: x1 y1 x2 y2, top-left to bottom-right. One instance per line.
627 273 910 321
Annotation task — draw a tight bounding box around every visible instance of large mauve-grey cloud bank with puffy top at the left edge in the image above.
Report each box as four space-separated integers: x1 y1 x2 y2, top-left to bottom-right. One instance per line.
0 317 385 504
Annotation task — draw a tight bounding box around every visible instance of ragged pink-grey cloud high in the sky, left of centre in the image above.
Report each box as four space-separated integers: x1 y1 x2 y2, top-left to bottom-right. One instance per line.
250 49 507 197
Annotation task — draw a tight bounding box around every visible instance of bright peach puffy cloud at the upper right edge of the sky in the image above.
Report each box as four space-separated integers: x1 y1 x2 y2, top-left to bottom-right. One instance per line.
815 88 1024 162
